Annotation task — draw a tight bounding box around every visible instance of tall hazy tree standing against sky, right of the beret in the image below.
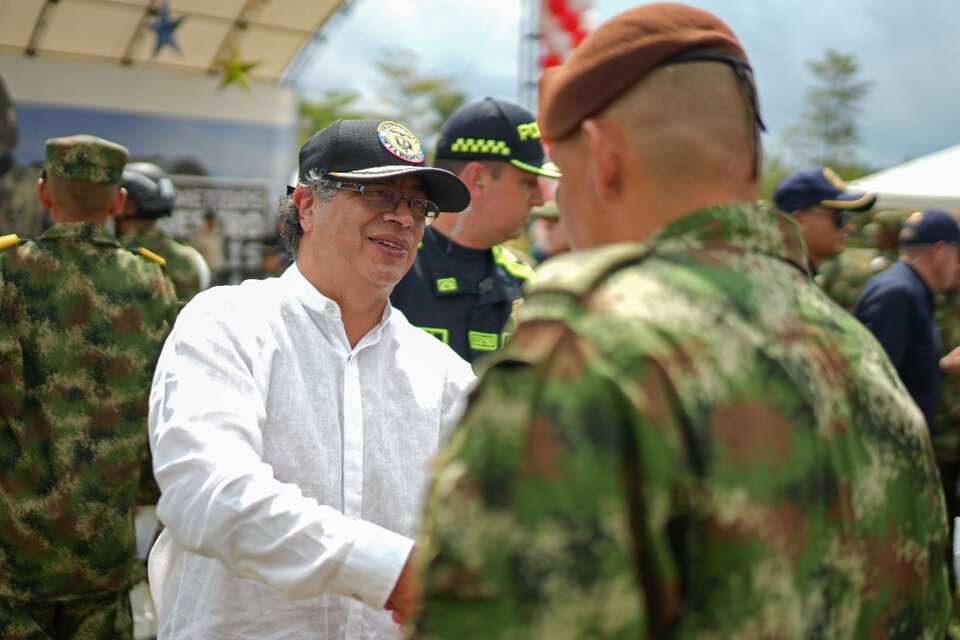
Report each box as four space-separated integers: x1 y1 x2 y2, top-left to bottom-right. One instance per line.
784 49 873 171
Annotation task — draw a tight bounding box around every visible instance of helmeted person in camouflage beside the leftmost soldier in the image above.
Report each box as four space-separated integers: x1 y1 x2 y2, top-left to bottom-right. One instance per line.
116 162 211 305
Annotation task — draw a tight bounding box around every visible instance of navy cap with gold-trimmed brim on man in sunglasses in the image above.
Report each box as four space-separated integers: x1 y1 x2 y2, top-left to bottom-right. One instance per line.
773 167 877 213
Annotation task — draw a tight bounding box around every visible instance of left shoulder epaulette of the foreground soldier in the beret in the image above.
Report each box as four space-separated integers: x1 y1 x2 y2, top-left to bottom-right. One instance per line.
527 243 650 298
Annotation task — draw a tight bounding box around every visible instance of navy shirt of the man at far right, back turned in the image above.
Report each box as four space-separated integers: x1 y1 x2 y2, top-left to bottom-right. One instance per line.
854 262 942 428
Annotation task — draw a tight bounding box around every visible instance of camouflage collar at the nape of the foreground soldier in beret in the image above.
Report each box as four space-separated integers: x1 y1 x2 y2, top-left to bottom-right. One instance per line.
643 204 806 271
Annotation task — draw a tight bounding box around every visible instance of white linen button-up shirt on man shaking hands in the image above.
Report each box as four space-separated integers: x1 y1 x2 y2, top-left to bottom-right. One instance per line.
149 265 474 640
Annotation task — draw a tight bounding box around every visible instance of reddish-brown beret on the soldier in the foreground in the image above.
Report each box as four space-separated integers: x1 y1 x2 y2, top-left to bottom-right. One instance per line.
540 2 747 140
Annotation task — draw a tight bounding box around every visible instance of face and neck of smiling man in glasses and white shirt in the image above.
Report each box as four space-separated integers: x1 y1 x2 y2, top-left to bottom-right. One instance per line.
298 177 427 295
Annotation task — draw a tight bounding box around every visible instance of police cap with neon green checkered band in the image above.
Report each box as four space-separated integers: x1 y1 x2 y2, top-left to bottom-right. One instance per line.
437 98 560 178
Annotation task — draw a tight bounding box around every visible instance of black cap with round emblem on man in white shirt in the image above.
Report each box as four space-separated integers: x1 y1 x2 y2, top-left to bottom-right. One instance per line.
299 120 470 212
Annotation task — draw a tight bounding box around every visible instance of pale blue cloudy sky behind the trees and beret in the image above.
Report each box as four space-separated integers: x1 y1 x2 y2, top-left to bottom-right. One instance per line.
294 0 960 171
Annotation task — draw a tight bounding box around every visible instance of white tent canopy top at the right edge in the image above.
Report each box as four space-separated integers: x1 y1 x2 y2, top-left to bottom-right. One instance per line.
850 144 960 214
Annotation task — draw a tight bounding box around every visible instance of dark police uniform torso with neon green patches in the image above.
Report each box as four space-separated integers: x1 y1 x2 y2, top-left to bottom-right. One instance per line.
390 227 533 362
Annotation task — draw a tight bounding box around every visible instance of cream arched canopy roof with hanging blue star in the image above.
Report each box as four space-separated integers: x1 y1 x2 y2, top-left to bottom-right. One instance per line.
0 0 352 82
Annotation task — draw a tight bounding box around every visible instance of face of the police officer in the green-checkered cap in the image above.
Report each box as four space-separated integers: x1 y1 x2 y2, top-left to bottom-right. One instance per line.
482 163 544 243
